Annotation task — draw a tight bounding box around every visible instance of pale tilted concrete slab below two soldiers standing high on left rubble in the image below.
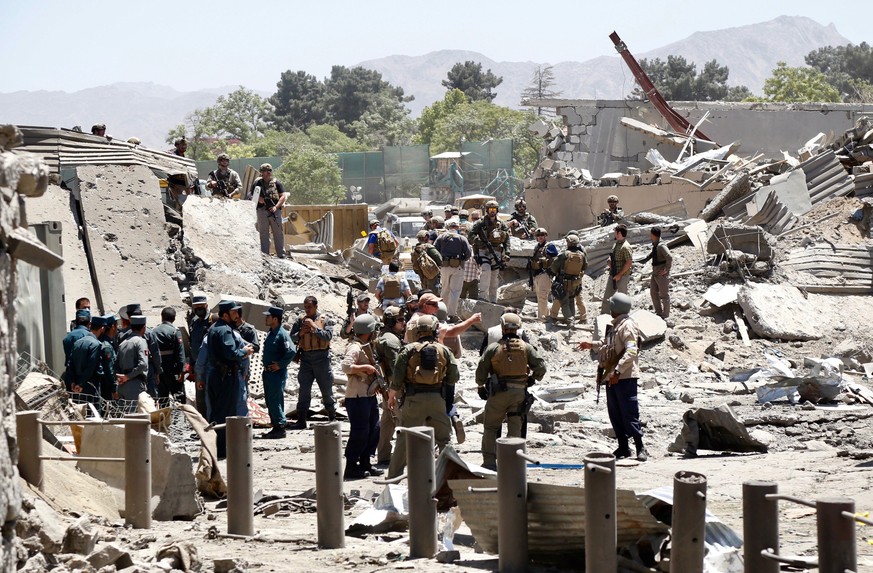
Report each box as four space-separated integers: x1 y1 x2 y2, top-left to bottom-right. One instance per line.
183 195 263 297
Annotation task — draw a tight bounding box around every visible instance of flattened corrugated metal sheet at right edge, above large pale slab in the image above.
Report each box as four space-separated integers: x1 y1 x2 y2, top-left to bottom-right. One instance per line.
780 243 873 294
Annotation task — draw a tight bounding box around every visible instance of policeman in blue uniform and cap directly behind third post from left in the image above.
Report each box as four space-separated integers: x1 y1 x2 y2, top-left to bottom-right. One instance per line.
205 300 255 459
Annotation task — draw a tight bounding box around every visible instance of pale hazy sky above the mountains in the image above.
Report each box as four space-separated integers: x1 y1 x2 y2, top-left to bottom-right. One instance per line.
0 0 869 92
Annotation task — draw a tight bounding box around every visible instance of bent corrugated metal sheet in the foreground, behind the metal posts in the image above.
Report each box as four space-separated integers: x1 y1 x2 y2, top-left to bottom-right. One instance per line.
449 480 668 559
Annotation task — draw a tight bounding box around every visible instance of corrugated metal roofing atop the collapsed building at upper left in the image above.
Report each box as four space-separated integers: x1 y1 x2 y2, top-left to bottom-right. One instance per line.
15 126 197 179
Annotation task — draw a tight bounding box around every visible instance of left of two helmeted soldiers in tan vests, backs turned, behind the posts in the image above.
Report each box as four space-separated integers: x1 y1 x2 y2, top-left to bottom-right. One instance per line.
388 312 460 478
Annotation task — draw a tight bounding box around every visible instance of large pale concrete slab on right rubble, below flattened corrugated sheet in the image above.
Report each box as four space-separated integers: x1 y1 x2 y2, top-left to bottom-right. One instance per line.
737 283 821 340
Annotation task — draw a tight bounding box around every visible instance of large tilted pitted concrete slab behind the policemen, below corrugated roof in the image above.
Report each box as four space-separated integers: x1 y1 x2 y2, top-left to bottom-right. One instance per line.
76 165 182 316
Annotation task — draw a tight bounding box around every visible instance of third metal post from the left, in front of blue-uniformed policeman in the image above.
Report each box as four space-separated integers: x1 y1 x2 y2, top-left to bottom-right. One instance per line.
226 416 255 536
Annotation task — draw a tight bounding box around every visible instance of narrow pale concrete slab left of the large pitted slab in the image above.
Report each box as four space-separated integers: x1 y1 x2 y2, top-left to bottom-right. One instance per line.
27 185 97 317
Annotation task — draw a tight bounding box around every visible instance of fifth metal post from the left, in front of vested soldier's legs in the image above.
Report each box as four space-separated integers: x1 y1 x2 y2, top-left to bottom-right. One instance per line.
401 426 437 559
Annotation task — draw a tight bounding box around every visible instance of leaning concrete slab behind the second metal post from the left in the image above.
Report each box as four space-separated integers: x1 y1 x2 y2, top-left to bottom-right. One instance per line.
77 425 200 521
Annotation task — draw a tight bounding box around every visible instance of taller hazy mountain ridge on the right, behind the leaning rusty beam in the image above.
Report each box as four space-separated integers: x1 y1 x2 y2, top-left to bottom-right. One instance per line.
360 16 849 115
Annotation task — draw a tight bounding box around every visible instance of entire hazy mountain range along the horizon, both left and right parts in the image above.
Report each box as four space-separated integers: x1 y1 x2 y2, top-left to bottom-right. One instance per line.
0 16 849 148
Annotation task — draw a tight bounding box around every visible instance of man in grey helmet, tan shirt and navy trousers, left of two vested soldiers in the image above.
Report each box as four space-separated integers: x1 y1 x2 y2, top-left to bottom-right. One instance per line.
342 314 383 480
